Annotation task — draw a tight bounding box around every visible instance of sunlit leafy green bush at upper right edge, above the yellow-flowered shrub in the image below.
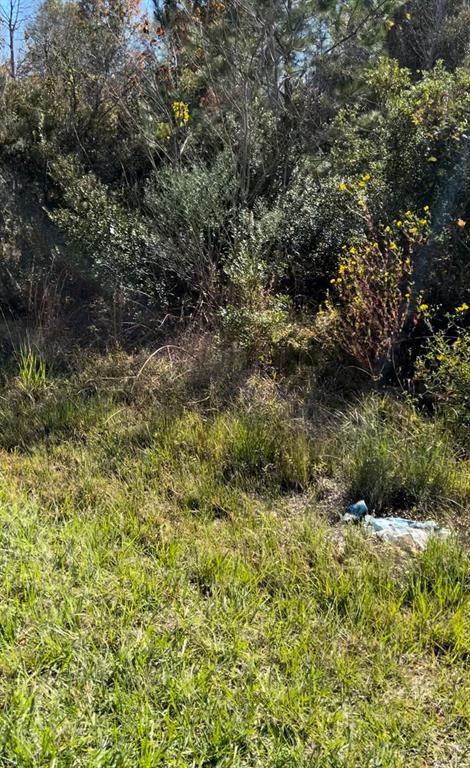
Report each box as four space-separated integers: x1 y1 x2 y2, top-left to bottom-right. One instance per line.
330 59 470 219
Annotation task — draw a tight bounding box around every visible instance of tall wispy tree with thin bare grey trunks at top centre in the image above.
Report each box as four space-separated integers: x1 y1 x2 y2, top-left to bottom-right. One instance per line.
140 0 397 192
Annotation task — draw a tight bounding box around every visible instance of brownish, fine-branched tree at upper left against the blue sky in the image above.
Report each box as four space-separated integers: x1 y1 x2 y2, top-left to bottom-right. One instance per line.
23 0 143 180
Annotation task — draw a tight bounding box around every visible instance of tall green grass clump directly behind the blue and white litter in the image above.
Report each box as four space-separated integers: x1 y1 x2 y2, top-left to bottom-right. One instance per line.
340 396 470 512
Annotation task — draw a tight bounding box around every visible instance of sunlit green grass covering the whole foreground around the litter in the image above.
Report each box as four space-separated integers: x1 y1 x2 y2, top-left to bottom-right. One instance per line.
0 352 470 768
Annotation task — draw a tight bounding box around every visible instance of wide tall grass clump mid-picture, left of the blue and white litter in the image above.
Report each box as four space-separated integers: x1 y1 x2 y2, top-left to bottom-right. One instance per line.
112 407 315 509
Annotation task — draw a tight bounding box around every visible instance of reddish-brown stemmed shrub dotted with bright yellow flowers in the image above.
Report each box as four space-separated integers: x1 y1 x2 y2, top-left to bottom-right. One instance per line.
317 174 429 375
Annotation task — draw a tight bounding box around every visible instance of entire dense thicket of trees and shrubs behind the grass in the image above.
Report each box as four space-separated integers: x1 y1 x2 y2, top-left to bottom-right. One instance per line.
0 0 470 376
